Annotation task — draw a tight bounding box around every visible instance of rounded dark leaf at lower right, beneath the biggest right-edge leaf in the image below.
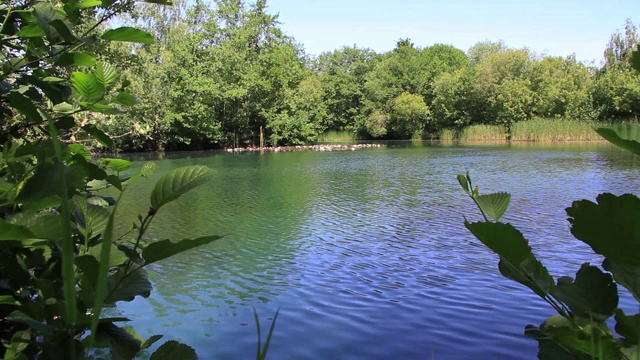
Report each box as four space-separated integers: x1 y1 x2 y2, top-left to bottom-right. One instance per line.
553 263 618 321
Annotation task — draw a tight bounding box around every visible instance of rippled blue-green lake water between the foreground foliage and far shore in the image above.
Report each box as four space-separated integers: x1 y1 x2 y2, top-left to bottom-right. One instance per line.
114 143 640 359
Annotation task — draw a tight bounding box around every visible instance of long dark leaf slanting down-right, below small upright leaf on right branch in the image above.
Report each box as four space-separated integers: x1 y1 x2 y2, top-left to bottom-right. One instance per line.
465 222 554 297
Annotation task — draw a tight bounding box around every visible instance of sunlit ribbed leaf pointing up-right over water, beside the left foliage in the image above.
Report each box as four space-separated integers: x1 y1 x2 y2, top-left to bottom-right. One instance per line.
151 166 213 210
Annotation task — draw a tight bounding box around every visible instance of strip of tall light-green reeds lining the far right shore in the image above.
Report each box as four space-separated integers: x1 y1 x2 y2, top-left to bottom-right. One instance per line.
440 118 602 142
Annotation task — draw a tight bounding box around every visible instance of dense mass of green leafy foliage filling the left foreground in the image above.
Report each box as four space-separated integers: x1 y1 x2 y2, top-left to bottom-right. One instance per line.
0 0 225 359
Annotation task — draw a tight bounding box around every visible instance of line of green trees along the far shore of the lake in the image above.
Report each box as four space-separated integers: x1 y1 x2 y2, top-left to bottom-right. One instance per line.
100 0 640 150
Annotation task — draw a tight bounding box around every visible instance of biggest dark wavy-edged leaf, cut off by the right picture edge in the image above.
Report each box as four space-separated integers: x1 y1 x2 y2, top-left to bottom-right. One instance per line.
566 193 640 267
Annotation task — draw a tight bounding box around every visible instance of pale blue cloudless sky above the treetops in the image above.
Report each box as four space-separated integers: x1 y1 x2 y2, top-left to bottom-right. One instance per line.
267 0 640 64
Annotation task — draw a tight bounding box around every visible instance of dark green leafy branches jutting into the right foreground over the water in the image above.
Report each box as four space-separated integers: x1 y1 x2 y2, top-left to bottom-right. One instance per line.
458 126 640 359
